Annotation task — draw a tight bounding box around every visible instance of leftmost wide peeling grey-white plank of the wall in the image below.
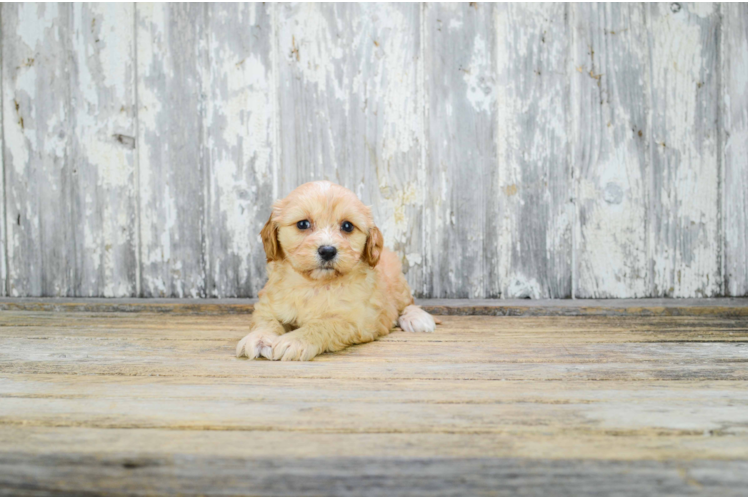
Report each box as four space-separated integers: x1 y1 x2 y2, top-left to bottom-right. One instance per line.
2 2 75 296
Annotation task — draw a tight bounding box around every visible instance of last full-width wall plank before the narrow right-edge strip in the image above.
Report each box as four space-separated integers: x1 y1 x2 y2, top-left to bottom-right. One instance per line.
647 3 722 297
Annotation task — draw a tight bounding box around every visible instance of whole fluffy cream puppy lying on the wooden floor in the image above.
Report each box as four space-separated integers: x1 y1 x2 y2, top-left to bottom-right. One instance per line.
236 181 435 361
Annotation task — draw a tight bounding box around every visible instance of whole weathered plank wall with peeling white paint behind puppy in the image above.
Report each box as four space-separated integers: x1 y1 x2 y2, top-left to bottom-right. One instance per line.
0 2 748 298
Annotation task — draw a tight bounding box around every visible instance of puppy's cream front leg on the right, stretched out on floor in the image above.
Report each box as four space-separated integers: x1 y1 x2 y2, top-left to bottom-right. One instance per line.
273 321 376 361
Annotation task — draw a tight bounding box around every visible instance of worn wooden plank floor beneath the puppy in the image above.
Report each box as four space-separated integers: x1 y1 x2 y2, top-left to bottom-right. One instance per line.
0 302 748 495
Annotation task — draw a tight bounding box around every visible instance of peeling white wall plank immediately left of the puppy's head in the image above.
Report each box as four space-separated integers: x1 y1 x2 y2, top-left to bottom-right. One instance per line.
205 2 278 297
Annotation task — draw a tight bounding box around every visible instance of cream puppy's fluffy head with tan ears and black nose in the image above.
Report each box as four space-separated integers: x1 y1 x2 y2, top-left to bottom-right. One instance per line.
260 181 384 280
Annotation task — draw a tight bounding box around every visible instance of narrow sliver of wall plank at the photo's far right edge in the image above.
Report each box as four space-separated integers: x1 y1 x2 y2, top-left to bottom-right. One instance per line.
720 2 748 296
